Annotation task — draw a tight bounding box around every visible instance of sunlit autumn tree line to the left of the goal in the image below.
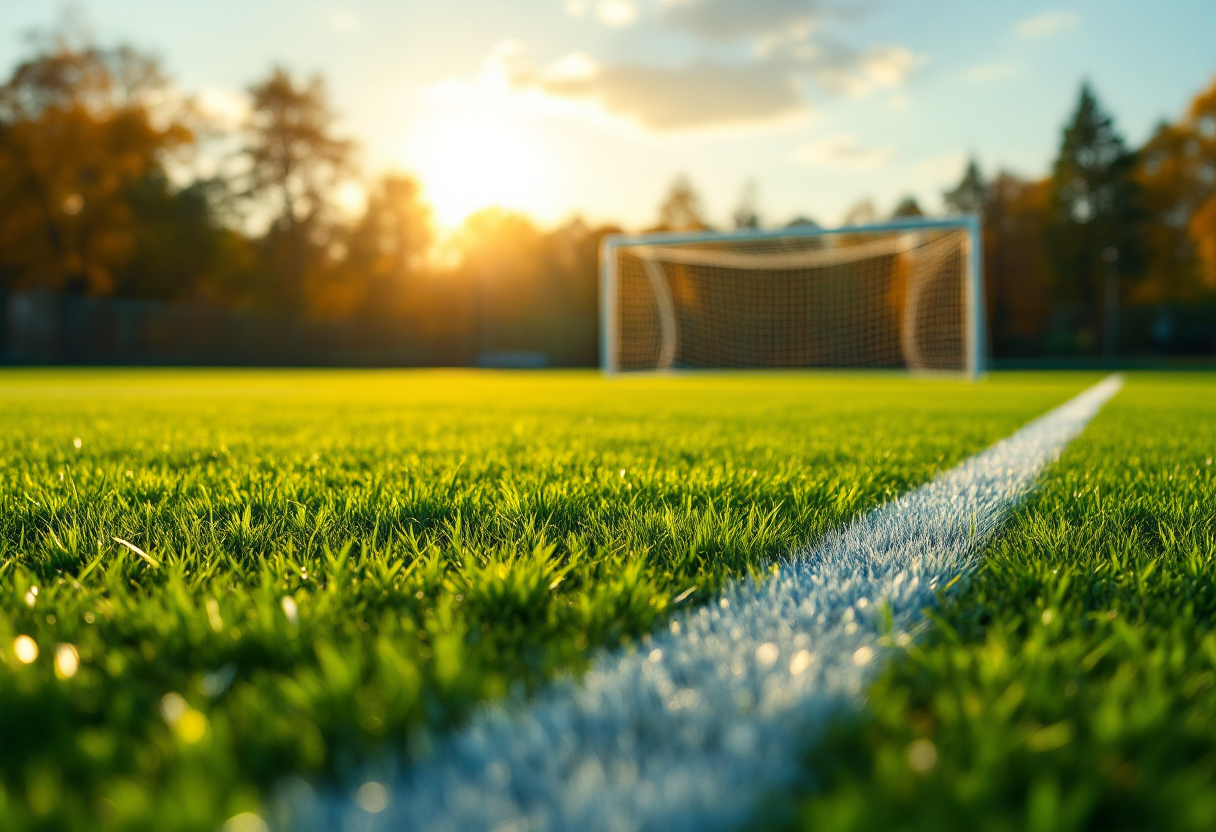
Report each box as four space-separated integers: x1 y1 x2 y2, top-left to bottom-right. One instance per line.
0 34 617 364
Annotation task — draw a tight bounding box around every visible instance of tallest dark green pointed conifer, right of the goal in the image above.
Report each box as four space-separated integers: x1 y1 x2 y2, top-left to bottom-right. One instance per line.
1046 84 1143 354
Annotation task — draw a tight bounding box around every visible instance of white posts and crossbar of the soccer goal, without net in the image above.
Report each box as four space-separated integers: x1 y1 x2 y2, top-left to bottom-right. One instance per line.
599 214 987 380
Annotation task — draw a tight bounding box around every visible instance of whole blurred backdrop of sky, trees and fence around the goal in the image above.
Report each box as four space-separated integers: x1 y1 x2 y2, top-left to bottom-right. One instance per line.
0 0 1216 367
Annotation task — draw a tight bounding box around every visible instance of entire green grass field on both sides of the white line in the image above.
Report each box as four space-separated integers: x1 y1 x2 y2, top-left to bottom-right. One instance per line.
0 371 1201 830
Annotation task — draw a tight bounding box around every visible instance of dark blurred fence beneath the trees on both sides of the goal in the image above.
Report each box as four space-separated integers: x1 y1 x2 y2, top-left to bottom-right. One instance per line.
0 291 1216 367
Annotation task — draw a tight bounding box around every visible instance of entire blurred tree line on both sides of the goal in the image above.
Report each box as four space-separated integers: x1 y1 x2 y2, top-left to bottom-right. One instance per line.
0 34 1216 364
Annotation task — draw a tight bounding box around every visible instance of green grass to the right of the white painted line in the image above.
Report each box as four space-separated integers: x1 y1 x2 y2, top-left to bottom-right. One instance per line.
796 376 1216 832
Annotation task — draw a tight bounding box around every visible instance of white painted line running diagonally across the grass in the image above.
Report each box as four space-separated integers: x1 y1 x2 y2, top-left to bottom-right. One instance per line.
288 376 1122 832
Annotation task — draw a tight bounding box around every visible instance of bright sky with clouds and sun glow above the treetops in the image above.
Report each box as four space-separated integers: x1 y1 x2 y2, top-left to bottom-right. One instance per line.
0 0 1216 229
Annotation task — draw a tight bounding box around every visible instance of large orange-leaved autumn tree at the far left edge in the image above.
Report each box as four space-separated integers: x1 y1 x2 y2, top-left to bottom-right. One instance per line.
0 35 193 293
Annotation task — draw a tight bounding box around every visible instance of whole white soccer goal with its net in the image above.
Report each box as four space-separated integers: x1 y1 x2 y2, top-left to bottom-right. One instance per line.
601 217 984 377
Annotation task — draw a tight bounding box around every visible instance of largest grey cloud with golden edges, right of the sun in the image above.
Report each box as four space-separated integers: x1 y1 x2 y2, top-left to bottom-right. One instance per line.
449 0 925 133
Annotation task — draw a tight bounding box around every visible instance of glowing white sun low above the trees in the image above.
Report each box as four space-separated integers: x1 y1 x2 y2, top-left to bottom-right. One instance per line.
405 96 553 229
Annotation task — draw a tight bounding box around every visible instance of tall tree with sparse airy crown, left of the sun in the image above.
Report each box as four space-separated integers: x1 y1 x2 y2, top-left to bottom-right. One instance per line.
244 68 353 309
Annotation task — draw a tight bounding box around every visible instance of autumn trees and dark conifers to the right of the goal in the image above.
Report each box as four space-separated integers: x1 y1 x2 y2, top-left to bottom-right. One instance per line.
945 81 1216 358
